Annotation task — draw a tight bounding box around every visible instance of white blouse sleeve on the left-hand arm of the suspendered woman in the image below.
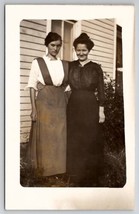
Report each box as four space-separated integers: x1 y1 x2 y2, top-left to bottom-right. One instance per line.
26 60 39 90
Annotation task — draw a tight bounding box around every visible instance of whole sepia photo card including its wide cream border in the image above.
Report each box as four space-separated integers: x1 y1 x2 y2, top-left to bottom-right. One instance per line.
5 5 135 210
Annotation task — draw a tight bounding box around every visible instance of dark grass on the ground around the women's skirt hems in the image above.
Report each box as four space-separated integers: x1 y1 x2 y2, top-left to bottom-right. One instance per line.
20 144 126 188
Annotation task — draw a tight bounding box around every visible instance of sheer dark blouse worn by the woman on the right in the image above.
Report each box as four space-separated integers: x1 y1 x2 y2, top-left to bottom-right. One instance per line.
69 60 104 106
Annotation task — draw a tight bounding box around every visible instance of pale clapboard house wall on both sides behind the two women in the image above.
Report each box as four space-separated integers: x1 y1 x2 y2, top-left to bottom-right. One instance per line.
20 19 115 143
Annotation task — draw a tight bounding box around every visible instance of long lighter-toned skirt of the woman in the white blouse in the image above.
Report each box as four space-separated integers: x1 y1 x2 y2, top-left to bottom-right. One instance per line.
28 86 67 176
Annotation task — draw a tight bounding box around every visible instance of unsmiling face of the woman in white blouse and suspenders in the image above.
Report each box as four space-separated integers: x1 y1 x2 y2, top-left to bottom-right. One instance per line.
48 40 61 57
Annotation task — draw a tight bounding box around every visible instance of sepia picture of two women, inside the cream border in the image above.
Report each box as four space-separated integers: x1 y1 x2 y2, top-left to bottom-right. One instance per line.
20 19 126 187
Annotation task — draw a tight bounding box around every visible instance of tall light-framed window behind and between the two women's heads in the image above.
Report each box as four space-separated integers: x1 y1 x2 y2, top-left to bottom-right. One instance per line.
51 20 75 61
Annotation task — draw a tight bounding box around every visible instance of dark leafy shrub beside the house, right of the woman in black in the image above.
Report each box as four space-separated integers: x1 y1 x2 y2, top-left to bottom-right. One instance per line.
104 72 125 152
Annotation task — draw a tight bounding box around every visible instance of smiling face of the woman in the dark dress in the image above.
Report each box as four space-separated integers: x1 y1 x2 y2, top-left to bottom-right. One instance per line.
75 44 89 61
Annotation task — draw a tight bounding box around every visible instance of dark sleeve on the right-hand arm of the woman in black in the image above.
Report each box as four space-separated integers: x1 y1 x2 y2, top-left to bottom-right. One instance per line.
97 65 105 106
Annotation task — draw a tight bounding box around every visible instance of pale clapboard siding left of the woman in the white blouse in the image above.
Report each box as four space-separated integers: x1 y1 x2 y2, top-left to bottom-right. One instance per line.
20 20 47 143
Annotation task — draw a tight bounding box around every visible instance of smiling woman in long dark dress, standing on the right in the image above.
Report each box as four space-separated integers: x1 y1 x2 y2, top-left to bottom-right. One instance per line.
67 33 105 187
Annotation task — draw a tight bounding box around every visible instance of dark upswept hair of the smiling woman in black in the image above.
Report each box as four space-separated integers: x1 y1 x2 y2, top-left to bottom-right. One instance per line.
73 33 94 51
